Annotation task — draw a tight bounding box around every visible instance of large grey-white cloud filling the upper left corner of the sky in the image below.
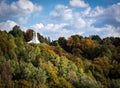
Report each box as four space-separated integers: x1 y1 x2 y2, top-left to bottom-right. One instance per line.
0 0 42 22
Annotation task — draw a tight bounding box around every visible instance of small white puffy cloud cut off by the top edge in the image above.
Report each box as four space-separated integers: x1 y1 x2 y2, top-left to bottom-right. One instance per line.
70 0 89 8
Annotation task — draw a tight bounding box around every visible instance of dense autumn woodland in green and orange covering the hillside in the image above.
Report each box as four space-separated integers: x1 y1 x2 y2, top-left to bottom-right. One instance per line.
0 25 120 88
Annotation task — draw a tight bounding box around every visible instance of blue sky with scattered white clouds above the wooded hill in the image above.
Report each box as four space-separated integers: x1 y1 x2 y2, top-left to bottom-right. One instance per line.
0 0 120 40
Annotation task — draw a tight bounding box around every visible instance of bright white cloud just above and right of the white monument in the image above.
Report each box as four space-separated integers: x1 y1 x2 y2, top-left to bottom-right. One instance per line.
32 23 71 40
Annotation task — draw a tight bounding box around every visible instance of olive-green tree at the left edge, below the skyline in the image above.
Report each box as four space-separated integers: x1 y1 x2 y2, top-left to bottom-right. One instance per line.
0 31 17 59
